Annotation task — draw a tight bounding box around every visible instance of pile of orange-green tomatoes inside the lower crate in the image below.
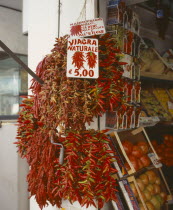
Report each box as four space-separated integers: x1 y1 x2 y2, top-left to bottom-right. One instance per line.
131 169 167 210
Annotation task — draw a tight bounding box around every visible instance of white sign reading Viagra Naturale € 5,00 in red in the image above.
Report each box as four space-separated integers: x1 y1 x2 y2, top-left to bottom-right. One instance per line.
67 38 99 79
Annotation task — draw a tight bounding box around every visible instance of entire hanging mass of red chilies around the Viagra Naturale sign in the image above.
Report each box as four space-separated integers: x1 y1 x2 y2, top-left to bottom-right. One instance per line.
15 34 139 209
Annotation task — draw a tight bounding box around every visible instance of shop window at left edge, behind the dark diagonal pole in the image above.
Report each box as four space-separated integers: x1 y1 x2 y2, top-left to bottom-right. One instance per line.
0 52 28 120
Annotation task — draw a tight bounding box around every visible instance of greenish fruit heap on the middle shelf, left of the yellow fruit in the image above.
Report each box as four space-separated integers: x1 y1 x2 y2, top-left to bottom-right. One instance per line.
141 89 171 120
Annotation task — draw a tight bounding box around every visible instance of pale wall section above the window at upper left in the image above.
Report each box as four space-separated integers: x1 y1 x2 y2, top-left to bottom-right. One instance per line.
0 7 27 54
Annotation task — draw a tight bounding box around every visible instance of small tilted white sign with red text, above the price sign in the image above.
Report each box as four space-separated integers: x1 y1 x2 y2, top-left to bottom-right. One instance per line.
70 18 106 37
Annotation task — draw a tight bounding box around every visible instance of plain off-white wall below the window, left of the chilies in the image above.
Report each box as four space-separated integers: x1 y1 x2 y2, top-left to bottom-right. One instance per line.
0 124 29 210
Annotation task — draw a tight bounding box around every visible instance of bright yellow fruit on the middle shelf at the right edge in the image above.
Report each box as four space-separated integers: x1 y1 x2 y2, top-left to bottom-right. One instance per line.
153 88 173 115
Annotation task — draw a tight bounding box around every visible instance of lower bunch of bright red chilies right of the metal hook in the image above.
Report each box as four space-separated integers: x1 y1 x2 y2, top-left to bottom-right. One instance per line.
54 130 116 208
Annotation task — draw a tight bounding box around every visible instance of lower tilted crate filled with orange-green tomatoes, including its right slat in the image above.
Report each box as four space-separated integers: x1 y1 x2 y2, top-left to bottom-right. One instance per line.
131 168 172 210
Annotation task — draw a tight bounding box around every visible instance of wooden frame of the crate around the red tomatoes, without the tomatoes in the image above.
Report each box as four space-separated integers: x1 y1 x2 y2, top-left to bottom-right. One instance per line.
110 127 159 175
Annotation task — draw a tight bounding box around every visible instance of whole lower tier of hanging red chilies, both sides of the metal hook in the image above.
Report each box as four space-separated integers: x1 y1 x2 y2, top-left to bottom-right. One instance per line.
17 101 117 209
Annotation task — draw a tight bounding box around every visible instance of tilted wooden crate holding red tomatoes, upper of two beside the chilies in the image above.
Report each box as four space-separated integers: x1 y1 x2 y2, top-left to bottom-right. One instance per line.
110 127 161 175
